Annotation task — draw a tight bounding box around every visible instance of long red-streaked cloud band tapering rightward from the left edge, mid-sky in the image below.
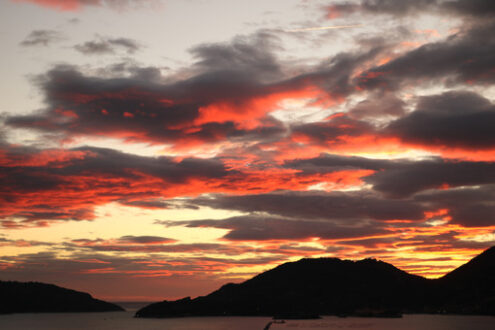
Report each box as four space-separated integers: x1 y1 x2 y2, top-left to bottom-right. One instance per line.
0 143 374 228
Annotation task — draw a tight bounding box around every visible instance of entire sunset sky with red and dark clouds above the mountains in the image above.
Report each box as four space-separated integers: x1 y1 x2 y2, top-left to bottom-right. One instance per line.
0 0 495 301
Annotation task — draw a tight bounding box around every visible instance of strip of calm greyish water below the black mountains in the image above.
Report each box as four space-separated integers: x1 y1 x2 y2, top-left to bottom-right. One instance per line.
0 312 495 330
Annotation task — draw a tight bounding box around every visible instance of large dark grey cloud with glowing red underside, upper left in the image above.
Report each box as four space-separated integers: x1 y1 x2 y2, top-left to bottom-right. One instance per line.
7 38 281 144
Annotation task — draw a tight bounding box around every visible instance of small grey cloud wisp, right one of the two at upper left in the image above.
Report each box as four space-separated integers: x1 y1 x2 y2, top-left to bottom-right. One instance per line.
74 37 141 55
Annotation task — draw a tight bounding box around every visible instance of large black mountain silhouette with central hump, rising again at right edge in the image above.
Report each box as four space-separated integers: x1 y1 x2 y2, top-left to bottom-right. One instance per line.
136 247 495 318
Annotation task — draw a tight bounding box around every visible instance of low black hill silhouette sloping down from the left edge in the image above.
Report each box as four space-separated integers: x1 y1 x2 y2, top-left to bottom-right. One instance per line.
0 281 124 314
